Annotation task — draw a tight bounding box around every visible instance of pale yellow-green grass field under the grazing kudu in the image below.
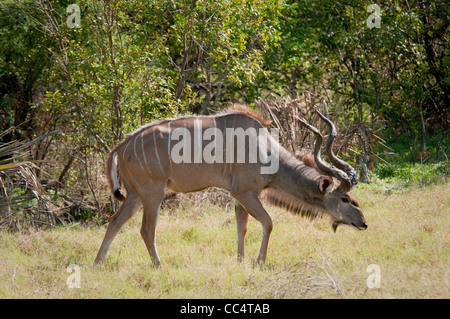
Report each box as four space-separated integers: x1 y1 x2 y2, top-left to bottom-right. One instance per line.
0 184 450 298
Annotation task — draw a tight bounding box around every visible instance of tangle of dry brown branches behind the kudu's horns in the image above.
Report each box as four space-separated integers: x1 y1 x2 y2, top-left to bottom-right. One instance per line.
256 91 386 183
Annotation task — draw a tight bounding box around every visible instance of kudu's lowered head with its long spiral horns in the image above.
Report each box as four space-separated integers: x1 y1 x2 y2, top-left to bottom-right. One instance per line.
298 111 367 231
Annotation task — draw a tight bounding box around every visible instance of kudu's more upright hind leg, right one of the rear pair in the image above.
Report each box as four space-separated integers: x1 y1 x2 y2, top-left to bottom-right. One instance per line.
141 184 165 267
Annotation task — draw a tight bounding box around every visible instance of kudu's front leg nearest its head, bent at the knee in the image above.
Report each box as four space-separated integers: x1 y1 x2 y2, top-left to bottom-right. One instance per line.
232 191 273 263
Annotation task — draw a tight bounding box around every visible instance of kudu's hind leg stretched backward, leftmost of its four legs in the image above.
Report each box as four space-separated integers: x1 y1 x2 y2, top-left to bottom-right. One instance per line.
94 190 142 264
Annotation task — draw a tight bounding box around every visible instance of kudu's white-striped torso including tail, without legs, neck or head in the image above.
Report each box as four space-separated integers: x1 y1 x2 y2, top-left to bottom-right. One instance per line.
107 108 280 199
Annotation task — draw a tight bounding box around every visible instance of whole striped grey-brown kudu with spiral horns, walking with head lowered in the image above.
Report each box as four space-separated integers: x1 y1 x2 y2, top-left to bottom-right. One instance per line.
95 106 367 266
